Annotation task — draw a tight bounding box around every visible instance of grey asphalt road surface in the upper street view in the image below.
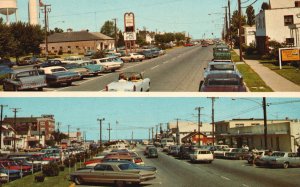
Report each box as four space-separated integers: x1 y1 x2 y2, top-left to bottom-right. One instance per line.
16 46 213 92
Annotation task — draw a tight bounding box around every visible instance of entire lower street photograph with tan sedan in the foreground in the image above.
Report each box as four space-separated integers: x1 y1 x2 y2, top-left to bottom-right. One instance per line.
0 97 300 187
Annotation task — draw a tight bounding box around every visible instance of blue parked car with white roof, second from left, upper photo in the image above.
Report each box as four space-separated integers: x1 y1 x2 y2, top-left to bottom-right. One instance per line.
39 66 81 86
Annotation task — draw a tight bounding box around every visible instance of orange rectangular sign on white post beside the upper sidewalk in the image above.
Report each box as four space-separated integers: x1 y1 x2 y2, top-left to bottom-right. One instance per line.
279 47 300 69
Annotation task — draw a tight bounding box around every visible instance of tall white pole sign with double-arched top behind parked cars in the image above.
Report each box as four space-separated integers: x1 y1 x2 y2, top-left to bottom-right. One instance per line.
124 12 136 53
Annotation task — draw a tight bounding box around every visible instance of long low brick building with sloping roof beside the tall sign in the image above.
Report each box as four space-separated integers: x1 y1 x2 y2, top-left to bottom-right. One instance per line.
40 30 115 54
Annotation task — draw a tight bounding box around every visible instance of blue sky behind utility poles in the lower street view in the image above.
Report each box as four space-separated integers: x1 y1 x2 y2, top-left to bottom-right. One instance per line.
0 97 300 140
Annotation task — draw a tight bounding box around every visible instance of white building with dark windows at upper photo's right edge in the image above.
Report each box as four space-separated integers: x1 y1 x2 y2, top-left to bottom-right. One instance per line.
255 0 300 53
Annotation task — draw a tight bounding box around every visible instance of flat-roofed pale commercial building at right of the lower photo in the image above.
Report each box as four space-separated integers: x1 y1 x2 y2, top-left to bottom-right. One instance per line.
215 118 300 151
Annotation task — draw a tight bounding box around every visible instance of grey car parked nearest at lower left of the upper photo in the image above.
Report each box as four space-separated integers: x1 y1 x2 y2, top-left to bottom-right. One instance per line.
3 69 47 91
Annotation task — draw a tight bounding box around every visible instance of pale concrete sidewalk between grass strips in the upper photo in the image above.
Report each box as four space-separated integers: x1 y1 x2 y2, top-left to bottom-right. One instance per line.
234 49 300 92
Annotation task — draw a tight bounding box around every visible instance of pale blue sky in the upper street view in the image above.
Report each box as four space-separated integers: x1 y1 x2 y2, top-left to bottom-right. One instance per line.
0 0 266 39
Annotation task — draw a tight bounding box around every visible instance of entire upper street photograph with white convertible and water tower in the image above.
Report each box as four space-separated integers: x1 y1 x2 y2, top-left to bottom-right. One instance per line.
0 0 300 92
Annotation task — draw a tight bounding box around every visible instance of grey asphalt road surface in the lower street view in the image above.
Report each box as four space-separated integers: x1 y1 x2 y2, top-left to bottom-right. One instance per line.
76 147 300 187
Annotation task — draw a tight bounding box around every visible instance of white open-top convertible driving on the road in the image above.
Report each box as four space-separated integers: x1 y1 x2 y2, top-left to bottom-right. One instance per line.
106 72 150 92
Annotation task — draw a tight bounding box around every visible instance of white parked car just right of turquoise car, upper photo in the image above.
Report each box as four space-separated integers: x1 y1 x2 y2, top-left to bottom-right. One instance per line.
93 56 124 72
